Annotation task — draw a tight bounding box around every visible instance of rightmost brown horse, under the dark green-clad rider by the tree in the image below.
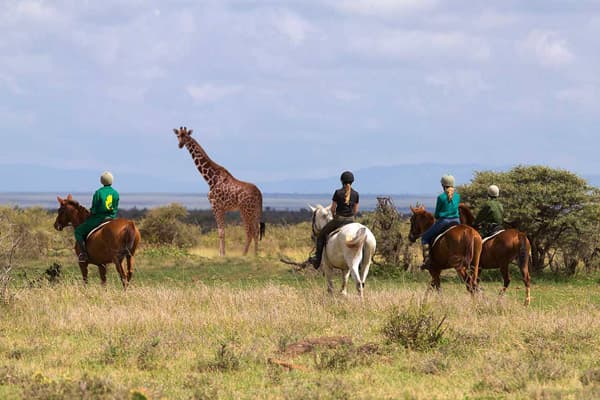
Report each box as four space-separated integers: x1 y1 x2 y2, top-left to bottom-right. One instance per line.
459 203 531 306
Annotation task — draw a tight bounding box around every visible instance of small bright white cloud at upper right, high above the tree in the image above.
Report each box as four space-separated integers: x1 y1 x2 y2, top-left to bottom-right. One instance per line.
519 30 575 68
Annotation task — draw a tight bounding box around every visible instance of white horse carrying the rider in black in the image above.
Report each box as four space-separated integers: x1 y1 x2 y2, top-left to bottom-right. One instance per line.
309 205 377 299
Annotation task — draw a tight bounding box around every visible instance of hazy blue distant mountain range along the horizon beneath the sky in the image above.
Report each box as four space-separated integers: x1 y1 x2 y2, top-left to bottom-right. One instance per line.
0 163 600 195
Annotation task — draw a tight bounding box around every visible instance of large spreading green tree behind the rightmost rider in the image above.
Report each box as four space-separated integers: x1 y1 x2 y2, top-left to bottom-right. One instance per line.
459 166 600 271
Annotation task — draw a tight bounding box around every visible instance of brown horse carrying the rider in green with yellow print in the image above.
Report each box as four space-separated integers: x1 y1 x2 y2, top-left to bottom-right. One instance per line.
54 195 140 289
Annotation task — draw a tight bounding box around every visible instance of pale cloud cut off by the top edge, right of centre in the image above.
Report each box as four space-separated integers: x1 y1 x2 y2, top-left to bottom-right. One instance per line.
334 0 437 18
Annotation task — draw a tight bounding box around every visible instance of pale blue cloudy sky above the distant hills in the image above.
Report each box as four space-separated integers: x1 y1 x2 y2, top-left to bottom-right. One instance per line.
0 0 600 191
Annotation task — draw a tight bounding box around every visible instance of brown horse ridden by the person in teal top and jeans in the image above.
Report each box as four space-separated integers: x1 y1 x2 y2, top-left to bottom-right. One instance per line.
408 206 481 292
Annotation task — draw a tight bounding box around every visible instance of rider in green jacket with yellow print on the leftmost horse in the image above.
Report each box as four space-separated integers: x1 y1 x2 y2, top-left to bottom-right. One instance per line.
75 171 119 262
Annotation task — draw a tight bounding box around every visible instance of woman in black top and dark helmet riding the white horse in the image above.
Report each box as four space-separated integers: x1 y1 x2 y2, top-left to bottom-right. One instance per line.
309 171 359 269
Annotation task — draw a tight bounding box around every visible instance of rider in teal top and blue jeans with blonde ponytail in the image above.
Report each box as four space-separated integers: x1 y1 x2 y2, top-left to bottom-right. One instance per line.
421 175 460 269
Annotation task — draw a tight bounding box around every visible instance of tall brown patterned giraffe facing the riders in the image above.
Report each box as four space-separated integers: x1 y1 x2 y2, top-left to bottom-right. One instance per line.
173 127 265 256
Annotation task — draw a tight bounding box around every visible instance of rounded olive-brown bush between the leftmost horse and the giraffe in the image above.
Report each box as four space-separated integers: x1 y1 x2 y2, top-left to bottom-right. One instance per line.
140 203 200 247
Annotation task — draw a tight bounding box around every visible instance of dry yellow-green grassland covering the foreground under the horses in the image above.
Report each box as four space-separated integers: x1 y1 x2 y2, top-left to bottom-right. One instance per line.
0 210 600 399
